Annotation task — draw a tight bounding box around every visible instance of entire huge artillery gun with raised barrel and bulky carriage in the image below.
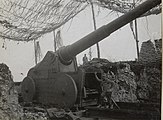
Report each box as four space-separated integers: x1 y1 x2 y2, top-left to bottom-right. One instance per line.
21 0 161 108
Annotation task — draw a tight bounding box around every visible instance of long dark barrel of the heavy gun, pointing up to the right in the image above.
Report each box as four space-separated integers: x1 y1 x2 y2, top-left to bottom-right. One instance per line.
59 0 161 63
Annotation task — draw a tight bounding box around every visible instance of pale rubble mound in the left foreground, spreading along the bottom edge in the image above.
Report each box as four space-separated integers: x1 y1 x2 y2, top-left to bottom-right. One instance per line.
0 63 47 120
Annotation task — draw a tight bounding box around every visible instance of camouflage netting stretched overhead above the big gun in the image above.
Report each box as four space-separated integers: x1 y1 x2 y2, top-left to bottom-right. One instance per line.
0 0 161 41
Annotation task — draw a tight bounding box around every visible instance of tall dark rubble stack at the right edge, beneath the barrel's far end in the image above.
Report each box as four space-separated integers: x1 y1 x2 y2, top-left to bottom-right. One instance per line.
137 39 162 102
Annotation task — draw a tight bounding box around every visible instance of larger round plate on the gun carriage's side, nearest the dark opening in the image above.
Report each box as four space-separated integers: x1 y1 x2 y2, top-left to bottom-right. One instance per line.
48 73 77 108
